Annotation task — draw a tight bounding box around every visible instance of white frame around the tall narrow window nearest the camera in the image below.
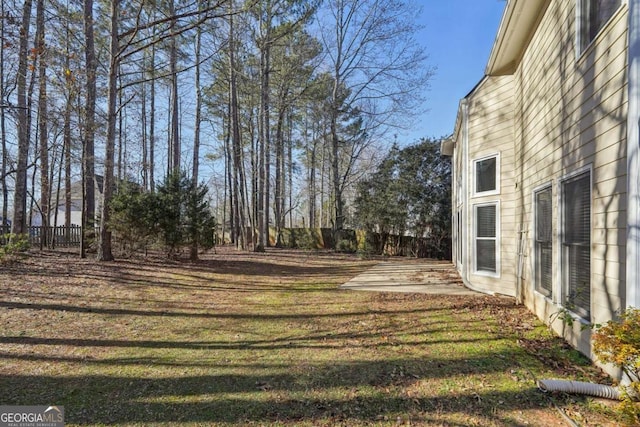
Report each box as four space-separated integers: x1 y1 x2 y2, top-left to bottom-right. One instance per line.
553 164 593 323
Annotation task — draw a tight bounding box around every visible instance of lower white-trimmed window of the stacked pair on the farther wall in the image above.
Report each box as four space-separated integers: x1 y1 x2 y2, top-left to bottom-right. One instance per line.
474 203 499 274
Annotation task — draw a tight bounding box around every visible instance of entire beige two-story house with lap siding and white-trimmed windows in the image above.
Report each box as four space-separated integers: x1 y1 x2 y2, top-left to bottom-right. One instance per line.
442 0 640 376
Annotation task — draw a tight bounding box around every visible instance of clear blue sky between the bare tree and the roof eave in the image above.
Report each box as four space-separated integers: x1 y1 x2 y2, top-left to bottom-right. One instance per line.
399 0 506 142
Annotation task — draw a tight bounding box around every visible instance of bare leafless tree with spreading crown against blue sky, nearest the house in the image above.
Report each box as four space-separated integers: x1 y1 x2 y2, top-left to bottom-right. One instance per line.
319 0 431 230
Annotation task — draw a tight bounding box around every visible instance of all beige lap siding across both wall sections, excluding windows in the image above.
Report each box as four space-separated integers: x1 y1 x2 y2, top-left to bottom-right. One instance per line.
456 0 628 366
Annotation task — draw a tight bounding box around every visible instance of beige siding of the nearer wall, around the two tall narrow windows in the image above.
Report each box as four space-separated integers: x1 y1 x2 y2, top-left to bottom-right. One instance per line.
516 0 627 354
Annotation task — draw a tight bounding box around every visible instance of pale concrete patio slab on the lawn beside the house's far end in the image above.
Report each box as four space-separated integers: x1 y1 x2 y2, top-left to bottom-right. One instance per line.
340 259 480 295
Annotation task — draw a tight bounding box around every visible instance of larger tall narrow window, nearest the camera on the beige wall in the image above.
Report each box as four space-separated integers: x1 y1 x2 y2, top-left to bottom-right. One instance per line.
562 172 591 319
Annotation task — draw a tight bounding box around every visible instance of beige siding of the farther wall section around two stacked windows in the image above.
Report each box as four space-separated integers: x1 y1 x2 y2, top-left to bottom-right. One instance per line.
454 76 517 296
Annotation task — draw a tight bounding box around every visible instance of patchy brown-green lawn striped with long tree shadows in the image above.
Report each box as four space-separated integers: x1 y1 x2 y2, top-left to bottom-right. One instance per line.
0 248 616 426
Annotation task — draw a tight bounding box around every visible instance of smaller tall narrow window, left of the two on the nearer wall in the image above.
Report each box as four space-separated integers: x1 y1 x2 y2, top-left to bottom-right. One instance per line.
534 187 553 297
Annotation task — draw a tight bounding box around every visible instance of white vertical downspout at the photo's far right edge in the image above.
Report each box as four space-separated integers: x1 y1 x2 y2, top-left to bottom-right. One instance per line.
623 0 640 308
